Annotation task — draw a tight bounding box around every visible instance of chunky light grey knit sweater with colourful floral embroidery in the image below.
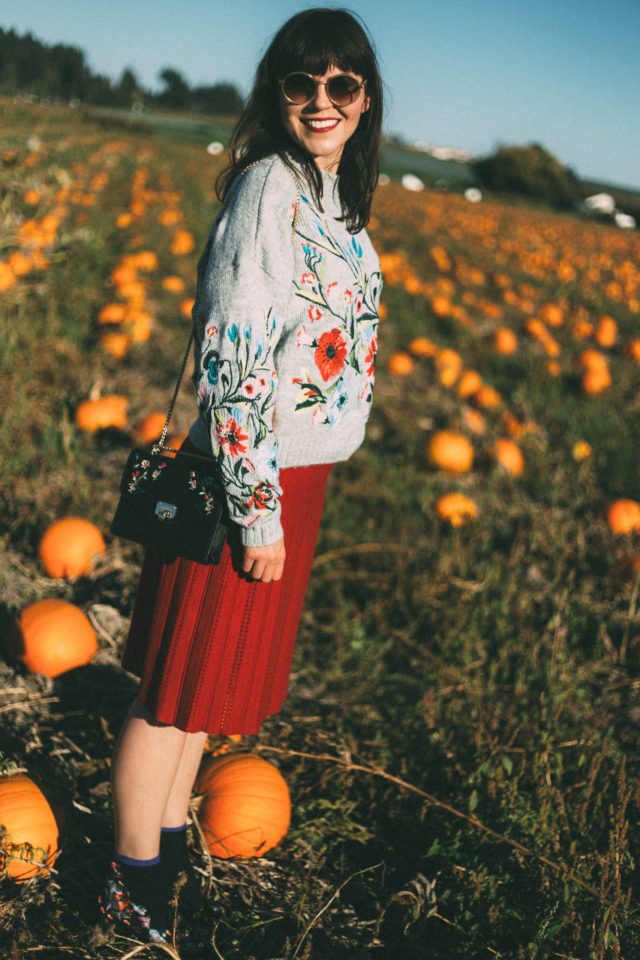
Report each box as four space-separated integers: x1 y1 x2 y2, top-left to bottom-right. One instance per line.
189 156 381 545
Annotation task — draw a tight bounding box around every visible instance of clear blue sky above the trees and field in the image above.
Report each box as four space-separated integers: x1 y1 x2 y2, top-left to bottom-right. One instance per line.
5 0 640 187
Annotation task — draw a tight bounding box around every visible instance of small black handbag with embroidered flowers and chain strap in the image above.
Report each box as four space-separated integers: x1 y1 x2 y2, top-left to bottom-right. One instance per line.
111 332 229 564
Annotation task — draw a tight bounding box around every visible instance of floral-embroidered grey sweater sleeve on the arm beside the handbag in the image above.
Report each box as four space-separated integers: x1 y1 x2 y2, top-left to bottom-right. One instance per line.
193 158 296 546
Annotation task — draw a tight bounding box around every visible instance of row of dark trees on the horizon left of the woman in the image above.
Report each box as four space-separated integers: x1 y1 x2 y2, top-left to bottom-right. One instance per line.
0 27 243 115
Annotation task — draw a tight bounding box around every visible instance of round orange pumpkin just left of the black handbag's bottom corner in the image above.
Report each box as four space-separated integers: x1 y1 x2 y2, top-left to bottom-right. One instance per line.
38 517 105 578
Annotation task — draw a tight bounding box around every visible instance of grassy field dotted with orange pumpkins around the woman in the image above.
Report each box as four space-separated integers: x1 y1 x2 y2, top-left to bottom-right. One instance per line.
0 101 640 960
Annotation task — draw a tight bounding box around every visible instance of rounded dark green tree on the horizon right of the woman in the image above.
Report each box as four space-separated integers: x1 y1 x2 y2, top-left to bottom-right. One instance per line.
472 143 578 209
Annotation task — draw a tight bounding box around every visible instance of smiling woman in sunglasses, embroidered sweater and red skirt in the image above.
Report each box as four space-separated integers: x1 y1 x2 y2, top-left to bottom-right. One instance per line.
101 8 382 940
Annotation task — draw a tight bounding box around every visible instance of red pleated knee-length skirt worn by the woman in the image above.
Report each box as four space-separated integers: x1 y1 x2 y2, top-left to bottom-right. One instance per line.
123 464 332 734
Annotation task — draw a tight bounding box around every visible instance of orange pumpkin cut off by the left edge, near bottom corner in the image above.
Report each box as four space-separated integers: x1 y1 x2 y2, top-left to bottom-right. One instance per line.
0 773 59 883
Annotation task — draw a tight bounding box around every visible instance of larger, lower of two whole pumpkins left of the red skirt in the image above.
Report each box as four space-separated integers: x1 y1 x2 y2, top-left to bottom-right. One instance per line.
5 597 98 677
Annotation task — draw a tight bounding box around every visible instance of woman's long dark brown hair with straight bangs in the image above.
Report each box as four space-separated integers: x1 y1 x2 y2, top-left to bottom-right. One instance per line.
216 7 382 233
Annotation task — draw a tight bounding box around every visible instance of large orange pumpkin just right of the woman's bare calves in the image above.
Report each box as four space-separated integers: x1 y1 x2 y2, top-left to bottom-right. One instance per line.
195 753 291 859
